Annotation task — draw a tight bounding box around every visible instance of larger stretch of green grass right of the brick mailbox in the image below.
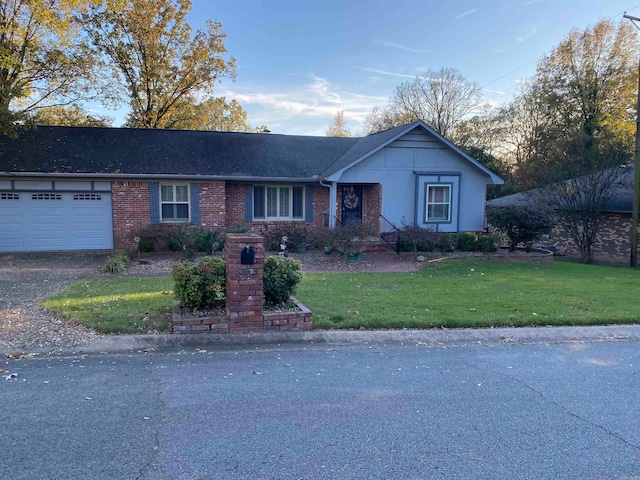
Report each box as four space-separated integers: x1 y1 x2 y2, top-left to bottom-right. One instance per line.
296 260 640 328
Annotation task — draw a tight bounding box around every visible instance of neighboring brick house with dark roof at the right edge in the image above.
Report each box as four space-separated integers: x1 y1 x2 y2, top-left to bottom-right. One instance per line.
487 166 635 262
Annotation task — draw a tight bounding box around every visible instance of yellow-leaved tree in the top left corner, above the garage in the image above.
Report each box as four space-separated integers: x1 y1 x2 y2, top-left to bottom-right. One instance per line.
0 0 102 133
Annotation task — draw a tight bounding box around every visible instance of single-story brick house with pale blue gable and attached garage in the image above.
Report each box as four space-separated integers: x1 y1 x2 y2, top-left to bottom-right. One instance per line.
0 121 502 252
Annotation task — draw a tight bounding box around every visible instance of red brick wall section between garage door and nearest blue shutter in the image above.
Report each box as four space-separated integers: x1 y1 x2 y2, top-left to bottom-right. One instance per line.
111 181 151 248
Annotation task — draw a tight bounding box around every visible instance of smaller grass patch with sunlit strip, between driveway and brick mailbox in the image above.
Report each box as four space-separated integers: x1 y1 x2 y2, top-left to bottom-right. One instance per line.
43 277 173 333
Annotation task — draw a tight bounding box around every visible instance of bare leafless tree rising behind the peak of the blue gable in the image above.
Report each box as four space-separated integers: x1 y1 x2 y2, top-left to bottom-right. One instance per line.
390 68 482 137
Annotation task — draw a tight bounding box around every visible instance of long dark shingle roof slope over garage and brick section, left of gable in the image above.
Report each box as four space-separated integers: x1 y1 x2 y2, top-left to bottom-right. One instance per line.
0 127 359 178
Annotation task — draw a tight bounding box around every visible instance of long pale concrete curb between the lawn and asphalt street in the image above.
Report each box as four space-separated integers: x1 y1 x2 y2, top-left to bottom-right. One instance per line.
4 325 640 355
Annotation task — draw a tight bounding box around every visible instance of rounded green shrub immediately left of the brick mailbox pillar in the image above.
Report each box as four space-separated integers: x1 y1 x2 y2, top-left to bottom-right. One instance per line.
173 257 226 308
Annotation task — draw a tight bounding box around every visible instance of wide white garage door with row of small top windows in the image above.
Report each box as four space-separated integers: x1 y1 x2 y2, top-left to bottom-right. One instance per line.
0 191 113 252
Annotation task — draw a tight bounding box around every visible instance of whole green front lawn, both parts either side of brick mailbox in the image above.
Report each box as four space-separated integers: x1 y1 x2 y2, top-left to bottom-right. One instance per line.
44 259 640 333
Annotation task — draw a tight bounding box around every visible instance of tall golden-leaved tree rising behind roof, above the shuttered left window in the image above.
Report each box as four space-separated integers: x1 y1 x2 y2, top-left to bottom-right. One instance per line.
84 0 236 128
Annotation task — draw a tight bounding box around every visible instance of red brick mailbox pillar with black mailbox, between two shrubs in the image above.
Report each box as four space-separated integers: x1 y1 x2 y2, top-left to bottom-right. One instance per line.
224 233 264 333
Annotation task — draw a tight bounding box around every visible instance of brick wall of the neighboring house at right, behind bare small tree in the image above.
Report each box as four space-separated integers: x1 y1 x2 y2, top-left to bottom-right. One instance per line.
541 213 631 262
